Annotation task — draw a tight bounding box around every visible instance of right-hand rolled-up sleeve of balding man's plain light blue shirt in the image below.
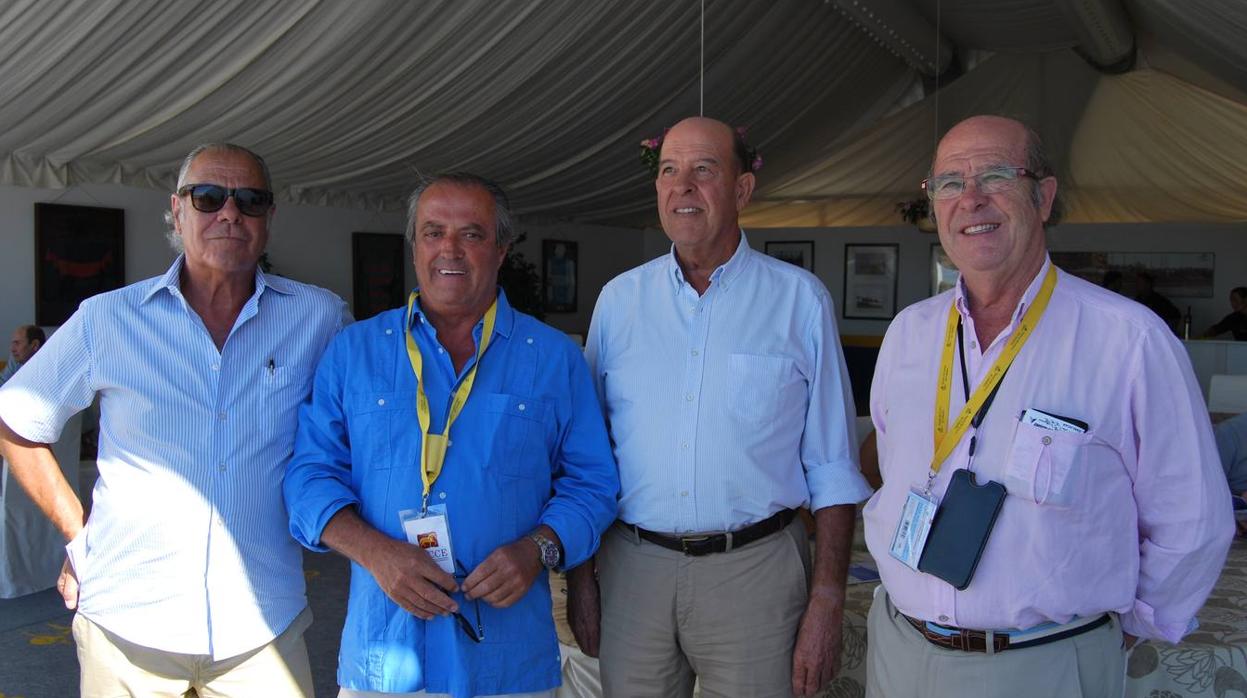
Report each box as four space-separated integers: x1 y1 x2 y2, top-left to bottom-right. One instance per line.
801 286 873 511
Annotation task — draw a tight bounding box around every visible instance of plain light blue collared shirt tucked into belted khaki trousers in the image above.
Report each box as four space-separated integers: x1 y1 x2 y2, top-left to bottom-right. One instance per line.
585 233 870 532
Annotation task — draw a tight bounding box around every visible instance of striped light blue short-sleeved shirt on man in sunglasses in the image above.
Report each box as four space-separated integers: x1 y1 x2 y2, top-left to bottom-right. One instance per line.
0 257 349 658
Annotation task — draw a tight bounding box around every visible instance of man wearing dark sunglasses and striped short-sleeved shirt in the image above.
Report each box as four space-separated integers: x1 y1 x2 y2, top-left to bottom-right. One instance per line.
0 143 350 698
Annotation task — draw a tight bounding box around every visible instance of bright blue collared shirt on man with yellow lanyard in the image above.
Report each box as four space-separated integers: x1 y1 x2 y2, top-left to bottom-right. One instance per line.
284 292 619 698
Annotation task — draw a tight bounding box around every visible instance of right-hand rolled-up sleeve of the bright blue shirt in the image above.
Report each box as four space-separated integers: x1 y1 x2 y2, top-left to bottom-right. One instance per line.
541 348 620 567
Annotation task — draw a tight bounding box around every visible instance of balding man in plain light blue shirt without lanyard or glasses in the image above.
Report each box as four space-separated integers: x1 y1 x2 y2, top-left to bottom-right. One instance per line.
569 118 870 698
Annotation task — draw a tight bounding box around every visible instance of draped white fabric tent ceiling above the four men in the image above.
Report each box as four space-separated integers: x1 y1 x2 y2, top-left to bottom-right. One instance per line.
0 0 1247 226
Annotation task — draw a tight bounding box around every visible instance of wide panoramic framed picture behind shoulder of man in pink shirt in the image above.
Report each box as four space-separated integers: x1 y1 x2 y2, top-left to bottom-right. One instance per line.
1049 252 1217 298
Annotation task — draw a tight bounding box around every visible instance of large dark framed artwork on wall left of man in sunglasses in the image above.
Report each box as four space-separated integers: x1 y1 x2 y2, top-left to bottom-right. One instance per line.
35 203 126 327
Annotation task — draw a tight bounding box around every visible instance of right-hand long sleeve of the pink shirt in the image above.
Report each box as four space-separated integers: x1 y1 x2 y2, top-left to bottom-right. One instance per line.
1121 332 1235 642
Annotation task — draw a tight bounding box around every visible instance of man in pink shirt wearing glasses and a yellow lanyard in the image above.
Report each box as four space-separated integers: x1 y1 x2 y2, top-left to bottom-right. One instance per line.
864 116 1233 698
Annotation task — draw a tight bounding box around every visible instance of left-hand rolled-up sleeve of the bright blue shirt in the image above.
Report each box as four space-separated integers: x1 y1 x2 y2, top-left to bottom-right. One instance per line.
282 333 359 552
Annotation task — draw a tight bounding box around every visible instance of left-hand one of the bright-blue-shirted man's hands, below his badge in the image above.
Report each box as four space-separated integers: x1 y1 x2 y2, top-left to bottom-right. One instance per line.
365 538 459 621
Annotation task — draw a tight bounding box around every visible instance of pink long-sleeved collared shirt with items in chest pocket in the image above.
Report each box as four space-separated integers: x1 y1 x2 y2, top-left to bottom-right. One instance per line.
864 262 1233 642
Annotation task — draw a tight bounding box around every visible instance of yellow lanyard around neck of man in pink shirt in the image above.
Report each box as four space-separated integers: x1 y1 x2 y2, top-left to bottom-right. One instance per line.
927 264 1056 492
